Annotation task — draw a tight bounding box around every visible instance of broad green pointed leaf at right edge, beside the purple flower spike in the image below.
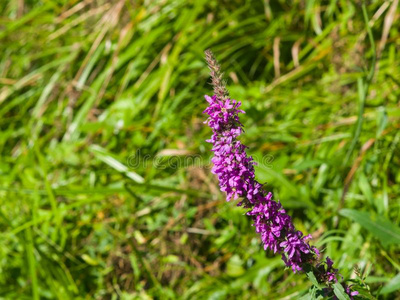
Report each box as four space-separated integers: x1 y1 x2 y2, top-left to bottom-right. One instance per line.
340 209 400 247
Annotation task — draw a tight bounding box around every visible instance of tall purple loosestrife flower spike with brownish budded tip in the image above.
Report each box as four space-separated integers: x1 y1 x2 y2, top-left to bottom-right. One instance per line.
204 51 355 296
